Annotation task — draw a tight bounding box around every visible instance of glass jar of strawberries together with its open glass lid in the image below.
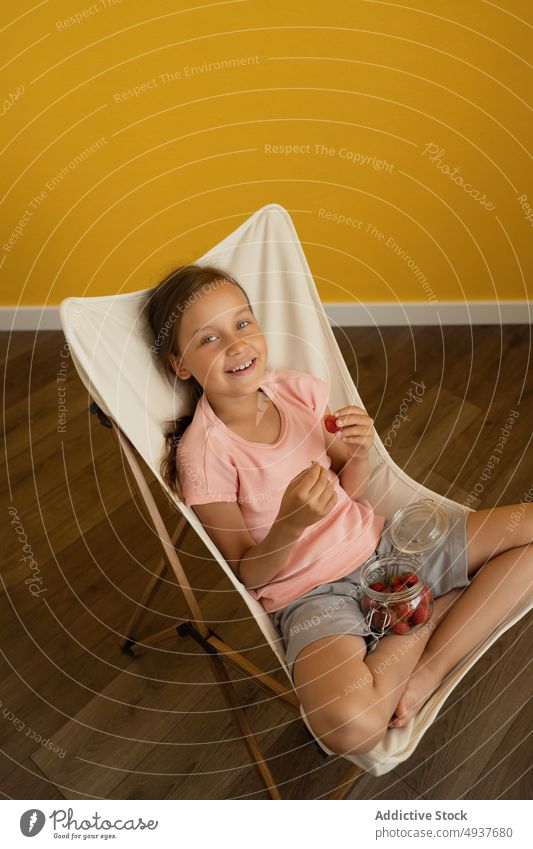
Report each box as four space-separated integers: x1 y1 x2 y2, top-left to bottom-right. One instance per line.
360 499 449 636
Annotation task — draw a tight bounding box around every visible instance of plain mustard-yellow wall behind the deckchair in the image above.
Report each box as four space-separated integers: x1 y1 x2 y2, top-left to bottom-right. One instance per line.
0 0 533 305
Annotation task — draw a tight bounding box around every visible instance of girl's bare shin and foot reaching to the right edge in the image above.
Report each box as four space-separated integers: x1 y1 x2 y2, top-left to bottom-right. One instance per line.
389 545 533 728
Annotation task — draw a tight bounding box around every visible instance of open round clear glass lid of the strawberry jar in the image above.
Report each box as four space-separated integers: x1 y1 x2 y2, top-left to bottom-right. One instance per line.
390 498 448 554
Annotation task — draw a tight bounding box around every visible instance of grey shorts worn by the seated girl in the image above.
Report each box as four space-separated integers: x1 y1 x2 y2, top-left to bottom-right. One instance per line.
269 505 471 678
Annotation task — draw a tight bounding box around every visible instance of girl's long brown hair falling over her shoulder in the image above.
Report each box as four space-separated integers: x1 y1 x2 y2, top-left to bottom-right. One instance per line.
143 264 253 500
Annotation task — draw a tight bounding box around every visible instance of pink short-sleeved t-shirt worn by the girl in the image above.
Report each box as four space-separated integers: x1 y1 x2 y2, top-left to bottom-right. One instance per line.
177 369 384 613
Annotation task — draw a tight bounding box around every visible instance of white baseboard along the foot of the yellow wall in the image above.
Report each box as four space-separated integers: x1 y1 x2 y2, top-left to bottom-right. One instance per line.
0 301 533 331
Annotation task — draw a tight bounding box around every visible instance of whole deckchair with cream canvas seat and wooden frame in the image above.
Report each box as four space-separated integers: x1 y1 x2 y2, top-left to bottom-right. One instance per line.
60 203 533 799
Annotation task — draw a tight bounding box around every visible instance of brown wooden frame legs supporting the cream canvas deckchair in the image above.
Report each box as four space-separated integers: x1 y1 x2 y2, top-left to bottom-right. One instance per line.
89 402 364 799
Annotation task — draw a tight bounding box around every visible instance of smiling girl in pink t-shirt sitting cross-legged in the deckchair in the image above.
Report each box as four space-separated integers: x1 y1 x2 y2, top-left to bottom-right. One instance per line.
146 265 533 754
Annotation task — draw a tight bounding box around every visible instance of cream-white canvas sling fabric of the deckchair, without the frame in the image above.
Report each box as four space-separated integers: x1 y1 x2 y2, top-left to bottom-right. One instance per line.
60 203 533 776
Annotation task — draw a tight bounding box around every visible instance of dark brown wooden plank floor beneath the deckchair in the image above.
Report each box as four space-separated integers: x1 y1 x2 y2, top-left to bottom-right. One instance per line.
0 326 533 799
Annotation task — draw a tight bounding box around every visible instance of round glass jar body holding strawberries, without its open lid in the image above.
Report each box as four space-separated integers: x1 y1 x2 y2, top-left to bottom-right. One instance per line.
360 552 433 636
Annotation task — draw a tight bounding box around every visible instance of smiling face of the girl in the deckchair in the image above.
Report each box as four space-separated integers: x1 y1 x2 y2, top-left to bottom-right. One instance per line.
170 280 268 395
